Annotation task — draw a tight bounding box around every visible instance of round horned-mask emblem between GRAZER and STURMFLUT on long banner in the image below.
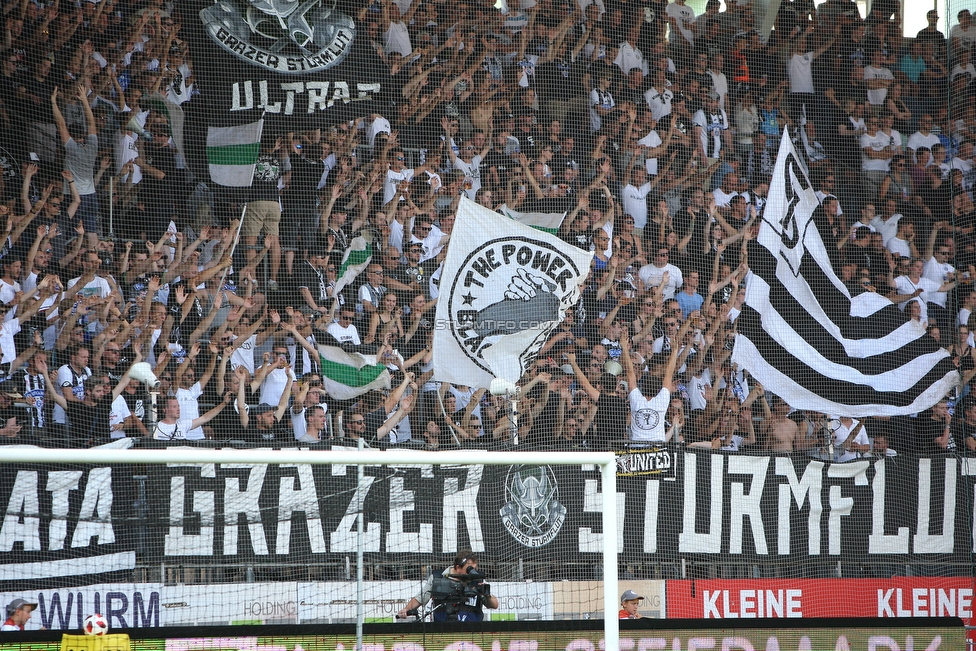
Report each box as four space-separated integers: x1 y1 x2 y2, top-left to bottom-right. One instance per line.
500 466 566 547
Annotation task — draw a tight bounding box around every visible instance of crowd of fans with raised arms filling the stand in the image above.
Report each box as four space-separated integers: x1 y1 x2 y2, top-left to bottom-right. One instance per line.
0 0 976 461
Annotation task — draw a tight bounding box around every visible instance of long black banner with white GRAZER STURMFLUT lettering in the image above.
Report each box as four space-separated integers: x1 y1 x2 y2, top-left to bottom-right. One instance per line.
0 450 976 589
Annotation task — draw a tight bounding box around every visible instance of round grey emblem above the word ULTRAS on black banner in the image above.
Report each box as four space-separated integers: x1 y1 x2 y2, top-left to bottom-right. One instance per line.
200 0 356 74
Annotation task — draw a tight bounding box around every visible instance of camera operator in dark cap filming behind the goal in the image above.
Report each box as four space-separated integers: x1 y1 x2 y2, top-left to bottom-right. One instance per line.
397 550 498 622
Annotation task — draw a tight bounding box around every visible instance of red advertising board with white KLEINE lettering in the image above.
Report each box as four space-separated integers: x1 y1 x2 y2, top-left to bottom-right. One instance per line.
666 577 976 640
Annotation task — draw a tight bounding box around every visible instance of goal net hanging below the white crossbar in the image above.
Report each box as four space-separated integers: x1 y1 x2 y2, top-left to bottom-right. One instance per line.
0 448 620 630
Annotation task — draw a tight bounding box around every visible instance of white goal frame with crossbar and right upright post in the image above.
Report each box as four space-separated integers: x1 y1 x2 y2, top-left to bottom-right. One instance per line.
4 446 619 651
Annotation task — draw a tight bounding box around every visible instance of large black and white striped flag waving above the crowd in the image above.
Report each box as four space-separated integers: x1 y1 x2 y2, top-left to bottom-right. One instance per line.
732 133 958 418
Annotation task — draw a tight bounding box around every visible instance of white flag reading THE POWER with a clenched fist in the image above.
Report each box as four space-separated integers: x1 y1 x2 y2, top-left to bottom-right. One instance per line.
434 197 593 388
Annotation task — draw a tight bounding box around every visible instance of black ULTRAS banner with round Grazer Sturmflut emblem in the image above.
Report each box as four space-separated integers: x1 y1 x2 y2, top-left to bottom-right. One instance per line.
183 0 388 129
